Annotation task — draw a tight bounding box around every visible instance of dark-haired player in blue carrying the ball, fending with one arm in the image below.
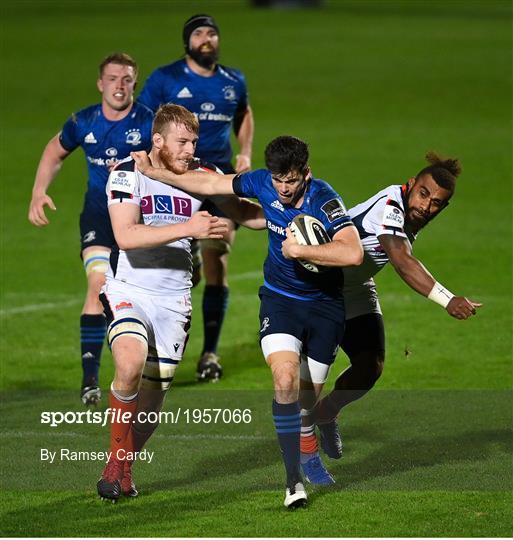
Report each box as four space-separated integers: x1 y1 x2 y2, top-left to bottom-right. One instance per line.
132 136 363 508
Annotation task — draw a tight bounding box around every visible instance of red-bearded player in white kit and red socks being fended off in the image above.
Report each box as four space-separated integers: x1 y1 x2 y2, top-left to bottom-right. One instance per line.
97 104 265 501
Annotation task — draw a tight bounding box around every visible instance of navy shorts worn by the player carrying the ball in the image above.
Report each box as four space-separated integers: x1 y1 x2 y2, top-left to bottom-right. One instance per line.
259 287 345 365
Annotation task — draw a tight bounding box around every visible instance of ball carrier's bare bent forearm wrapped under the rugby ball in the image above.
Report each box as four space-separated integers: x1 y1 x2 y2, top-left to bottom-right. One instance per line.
281 225 363 266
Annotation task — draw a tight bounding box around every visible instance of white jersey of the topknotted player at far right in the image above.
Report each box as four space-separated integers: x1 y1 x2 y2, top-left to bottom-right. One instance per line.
344 185 416 287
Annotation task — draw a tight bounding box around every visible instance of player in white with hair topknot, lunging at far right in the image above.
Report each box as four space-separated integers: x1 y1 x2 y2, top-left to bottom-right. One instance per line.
303 152 481 459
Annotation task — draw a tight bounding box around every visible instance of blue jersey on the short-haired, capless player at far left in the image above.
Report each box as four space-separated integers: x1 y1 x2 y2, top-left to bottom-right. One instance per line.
59 103 153 215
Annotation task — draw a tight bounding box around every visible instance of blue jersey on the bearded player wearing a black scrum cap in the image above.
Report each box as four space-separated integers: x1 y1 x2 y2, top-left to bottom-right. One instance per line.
138 59 248 165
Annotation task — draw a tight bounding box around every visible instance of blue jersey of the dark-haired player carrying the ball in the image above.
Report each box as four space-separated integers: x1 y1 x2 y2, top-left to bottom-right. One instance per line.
233 169 353 300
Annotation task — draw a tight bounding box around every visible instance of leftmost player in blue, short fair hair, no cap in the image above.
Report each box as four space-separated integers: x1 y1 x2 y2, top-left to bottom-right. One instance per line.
28 53 153 405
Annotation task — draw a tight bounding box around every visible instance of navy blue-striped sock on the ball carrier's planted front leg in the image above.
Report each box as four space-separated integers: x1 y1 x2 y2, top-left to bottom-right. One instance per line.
273 400 301 485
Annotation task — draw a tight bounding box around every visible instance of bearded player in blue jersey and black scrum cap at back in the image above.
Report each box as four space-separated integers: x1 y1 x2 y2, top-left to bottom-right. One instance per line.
138 15 254 381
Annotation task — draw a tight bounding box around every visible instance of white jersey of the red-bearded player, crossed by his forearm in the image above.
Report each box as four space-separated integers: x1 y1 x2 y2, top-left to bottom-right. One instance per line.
106 158 210 296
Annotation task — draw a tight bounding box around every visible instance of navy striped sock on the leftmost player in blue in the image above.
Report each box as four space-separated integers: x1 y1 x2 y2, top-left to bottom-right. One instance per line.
80 315 107 386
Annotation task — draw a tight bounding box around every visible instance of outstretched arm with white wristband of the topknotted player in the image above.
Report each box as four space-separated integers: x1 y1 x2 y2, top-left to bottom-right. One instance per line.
378 234 482 319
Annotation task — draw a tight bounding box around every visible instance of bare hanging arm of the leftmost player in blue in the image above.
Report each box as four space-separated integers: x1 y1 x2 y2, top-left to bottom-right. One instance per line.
28 134 70 227
